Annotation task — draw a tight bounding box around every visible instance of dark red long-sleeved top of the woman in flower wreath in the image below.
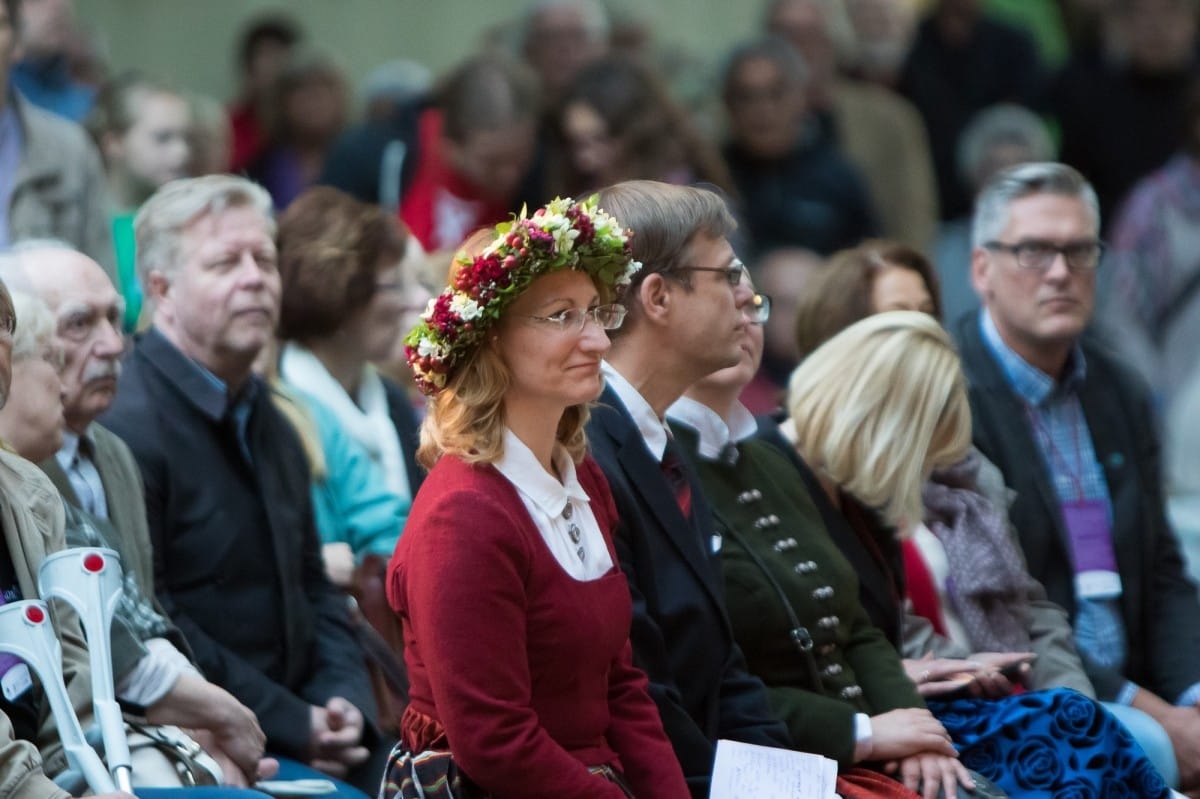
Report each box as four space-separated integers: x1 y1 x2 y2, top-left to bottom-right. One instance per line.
388 456 690 799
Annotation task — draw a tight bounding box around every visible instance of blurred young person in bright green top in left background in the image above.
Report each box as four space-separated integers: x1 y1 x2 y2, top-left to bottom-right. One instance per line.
88 72 191 330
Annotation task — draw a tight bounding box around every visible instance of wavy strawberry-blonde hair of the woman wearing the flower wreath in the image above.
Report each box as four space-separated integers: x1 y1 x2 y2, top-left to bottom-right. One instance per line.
416 229 592 469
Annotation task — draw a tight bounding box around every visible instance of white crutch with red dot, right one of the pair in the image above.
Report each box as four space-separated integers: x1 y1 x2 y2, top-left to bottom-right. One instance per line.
37 547 133 793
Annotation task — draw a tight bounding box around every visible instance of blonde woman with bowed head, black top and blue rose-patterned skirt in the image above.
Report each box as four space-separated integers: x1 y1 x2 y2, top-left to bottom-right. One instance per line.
768 311 1170 799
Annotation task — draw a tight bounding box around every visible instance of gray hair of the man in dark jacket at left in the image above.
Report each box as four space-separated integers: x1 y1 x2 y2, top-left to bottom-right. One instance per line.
133 175 275 287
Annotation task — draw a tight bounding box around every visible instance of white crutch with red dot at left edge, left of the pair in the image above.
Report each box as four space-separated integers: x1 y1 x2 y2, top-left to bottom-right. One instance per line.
0 600 116 793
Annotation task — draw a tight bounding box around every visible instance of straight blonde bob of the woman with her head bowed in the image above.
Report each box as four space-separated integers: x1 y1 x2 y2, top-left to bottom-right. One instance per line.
787 311 971 530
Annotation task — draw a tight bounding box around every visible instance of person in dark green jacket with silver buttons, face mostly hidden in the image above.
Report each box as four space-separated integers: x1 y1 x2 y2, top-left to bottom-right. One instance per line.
667 295 974 797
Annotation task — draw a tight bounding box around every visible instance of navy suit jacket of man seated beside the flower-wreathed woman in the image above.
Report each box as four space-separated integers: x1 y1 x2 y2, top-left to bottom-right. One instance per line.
588 389 791 799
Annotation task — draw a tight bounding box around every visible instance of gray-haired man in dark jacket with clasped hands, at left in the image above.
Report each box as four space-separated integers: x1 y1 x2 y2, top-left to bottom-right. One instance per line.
102 176 388 792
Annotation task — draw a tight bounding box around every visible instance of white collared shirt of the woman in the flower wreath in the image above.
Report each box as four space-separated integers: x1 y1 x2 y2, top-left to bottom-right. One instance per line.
494 428 612 582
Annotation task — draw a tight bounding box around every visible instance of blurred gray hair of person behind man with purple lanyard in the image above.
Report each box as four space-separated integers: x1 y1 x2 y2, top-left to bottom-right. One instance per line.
956 103 1058 192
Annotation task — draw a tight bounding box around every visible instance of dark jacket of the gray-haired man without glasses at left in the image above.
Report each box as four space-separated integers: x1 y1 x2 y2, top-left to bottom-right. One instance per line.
102 329 374 759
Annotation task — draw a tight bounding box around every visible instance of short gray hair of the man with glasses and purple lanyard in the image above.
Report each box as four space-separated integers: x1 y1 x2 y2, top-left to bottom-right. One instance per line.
971 161 1100 247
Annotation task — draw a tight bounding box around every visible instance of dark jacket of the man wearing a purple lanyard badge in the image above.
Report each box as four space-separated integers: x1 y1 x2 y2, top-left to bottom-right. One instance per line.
954 314 1200 702
